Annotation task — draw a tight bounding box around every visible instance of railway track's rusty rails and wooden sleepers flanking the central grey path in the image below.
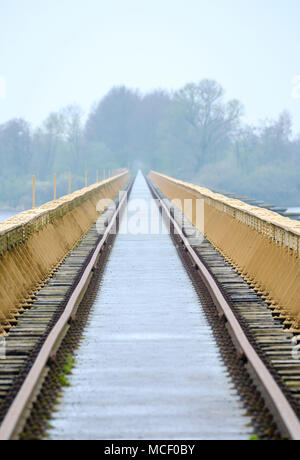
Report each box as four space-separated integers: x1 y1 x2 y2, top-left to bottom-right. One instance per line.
0 174 300 440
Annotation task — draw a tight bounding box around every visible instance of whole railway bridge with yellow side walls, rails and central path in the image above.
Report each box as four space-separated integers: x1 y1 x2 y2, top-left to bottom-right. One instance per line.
0 170 300 440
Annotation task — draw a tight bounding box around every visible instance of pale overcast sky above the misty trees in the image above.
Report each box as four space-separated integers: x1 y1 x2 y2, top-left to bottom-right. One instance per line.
0 0 300 132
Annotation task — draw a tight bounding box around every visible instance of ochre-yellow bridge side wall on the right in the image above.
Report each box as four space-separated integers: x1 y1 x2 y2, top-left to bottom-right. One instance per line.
150 172 300 332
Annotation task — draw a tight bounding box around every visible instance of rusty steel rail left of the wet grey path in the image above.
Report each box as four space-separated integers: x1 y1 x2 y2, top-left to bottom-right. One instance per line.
0 185 131 441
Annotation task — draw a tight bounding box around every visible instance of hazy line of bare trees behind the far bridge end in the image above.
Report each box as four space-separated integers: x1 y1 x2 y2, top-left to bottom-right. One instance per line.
0 79 300 209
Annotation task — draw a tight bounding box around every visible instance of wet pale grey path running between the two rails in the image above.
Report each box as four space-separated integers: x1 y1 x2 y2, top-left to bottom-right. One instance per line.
49 175 251 440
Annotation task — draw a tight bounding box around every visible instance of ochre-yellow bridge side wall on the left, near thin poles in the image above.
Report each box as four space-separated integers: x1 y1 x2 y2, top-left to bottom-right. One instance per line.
0 172 130 334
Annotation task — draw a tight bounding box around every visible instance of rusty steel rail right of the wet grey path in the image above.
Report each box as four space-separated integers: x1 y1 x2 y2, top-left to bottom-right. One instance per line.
147 178 300 441
